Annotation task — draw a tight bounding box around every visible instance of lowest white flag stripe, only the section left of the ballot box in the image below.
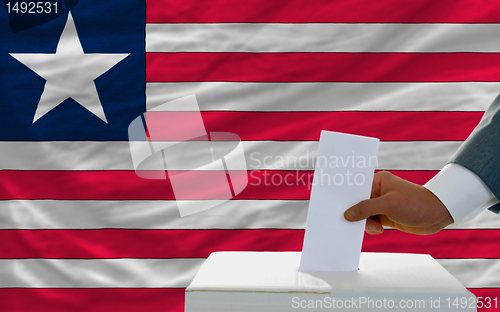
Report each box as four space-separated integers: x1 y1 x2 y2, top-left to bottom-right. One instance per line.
0 259 204 288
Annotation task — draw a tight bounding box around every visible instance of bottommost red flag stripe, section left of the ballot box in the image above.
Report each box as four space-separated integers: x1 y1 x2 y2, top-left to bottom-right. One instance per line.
0 288 184 312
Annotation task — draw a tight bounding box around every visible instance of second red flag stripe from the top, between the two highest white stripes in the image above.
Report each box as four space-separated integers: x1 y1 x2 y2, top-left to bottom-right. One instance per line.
146 52 500 82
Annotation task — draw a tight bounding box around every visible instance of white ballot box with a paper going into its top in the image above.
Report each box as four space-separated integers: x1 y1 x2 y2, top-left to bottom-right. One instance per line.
185 252 476 312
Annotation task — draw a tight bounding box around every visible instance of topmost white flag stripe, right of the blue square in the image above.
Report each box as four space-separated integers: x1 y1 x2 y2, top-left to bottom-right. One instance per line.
146 23 500 52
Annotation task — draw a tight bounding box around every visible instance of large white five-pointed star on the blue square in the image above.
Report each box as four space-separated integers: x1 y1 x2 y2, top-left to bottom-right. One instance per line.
10 13 129 123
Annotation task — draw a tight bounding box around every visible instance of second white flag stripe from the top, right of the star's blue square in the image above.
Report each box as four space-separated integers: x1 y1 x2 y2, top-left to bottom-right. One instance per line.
146 82 500 111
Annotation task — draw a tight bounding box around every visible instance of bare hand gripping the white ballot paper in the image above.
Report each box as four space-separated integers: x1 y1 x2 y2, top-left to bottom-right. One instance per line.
344 171 453 235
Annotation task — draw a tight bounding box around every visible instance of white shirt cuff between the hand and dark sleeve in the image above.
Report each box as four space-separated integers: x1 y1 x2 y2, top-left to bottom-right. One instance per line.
424 164 498 226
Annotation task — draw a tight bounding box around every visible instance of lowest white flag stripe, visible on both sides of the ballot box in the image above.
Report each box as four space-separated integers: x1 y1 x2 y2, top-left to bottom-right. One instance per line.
0 259 500 288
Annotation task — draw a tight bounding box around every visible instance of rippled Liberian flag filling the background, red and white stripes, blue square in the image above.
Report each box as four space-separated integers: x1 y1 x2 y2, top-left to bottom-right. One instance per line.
0 0 500 312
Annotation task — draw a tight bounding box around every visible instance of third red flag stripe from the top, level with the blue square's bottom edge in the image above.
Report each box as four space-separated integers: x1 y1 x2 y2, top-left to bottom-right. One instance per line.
147 111 480 141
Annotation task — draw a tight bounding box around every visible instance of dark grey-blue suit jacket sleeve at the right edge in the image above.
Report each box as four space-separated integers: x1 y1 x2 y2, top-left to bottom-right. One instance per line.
449 95 500 213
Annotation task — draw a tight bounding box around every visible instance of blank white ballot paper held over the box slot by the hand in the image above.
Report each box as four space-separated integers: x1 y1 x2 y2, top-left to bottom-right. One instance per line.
299 131 379 272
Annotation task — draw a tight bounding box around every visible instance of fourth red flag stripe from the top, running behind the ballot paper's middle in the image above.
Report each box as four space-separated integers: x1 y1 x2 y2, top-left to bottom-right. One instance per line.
0 170 437 200
